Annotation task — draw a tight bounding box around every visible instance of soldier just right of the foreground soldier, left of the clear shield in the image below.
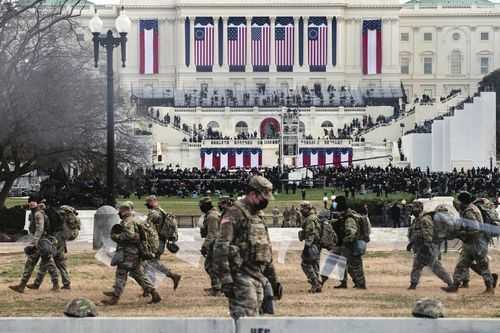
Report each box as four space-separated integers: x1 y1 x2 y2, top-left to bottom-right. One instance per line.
299 201 322 293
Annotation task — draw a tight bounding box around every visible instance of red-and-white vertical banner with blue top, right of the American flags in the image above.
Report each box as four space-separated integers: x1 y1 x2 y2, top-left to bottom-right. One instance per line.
362 20 382 75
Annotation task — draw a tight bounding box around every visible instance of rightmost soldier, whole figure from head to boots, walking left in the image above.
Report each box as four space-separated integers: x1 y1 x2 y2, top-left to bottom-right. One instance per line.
442 192 495 294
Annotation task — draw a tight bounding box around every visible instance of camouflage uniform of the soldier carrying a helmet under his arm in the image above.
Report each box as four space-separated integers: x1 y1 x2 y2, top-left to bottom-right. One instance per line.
111 214 154 298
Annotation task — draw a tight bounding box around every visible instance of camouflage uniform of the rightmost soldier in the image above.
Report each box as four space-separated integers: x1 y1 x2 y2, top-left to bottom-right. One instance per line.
453 203 494 288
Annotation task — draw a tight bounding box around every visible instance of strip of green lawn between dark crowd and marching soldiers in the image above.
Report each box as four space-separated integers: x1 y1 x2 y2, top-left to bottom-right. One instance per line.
6 188 413 215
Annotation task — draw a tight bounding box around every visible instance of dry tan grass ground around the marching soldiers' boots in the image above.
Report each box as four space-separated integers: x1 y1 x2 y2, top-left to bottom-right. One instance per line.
0 251 500 317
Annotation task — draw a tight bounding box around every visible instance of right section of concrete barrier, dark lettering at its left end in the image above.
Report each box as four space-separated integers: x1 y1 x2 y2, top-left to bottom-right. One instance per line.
236 318 500 333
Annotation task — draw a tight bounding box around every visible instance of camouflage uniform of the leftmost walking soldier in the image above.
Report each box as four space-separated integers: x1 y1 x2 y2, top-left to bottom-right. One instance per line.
15 208 59 288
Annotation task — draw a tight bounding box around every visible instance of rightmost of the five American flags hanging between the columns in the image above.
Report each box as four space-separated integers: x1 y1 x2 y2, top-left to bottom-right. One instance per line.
307 16 328 72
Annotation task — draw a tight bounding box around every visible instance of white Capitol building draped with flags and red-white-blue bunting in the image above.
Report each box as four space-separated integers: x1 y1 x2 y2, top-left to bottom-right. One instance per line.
83 0 500 168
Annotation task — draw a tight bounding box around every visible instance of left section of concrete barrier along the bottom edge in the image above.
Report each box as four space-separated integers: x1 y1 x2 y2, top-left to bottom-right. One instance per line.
0 318 235 333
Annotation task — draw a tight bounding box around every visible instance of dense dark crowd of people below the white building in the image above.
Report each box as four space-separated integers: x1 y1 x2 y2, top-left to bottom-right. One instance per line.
122 167 500 197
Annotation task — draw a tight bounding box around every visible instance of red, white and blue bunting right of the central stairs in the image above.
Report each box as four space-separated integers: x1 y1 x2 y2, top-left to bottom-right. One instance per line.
296 148 352 168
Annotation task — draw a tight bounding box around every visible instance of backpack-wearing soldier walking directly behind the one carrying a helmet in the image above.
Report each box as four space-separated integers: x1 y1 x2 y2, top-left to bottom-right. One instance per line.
146 195 182 290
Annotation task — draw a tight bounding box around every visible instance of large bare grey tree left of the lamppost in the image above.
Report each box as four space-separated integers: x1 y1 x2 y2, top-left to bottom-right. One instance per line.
0 0 144 208
